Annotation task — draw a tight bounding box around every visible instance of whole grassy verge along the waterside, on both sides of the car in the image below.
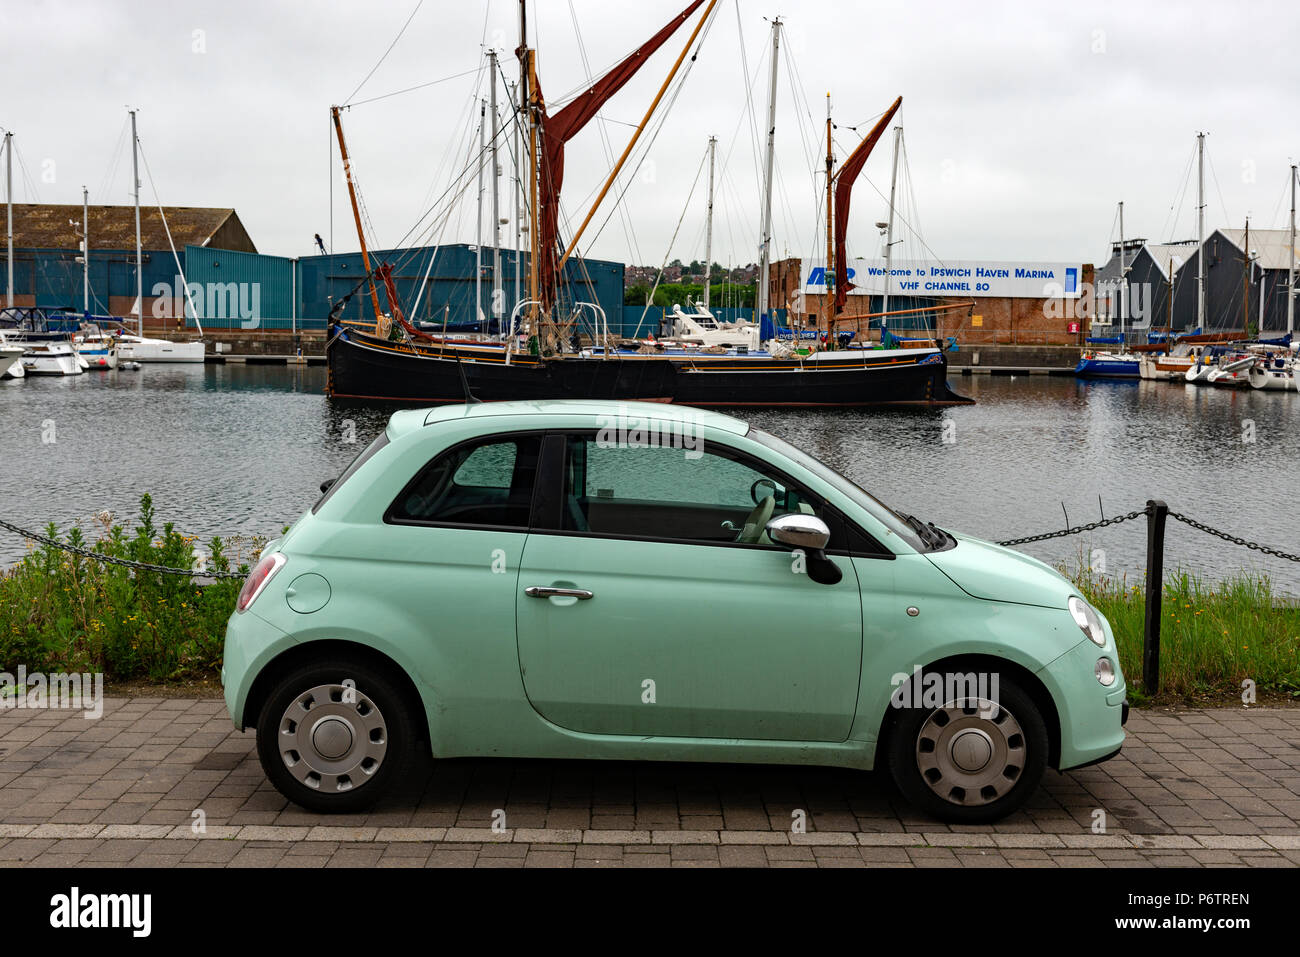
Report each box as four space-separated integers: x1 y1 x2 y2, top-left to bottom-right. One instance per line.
0 495 1300 702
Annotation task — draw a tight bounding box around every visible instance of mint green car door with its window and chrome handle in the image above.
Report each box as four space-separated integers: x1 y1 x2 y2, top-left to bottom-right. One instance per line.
516 433 862 741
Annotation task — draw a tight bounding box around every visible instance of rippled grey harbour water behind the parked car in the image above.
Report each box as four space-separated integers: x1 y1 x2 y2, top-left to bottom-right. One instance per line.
0 365 1300 596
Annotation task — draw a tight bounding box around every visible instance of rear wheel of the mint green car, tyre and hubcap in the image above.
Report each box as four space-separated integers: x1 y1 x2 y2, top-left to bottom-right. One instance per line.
257 658 416 814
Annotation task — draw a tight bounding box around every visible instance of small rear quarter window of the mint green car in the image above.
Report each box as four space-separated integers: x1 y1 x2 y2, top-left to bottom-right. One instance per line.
385 434 542 528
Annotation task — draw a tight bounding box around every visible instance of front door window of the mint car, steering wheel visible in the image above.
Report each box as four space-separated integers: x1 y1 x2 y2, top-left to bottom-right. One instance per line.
560 436 842 549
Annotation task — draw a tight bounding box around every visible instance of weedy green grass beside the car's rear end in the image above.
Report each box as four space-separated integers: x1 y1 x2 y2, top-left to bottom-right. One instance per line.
0 495 261 681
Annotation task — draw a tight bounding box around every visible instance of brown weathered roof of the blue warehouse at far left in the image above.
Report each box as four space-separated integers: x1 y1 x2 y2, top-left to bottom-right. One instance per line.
13 203 257 252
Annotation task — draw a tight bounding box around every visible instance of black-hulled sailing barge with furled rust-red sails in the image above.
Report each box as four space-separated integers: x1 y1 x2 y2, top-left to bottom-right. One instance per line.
325 0 971 406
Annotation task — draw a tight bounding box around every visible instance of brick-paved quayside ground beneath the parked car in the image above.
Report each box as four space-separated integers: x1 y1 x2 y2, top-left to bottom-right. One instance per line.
0 698 1300 867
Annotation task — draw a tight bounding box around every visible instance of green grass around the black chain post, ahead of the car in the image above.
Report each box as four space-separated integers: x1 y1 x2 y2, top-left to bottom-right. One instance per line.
1073 571 1300 702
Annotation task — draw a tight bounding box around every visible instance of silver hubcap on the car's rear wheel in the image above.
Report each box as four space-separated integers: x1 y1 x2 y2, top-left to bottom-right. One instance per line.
280 684 389 793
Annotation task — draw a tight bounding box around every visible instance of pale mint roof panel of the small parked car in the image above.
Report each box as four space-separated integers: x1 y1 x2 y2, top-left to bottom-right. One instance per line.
390 399 749 436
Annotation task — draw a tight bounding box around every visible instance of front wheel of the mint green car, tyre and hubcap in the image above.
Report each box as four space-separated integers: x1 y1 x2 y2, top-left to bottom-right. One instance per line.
887 676 1049 824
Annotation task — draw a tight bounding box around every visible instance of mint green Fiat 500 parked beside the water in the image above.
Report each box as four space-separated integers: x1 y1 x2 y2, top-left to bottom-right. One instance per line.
222 402 1128 822
